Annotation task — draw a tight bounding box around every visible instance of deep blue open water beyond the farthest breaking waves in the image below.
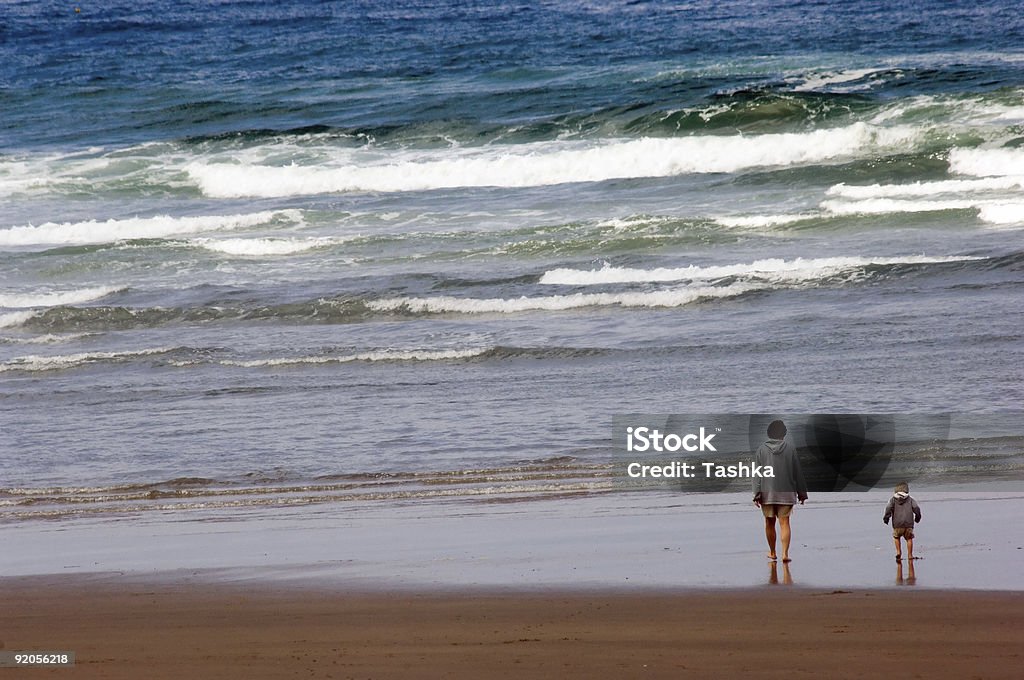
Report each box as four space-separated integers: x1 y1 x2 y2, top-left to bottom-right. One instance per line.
6 1 1024 148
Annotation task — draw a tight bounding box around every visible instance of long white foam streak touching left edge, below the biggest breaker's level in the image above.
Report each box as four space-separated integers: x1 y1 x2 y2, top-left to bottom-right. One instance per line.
0 210 301 246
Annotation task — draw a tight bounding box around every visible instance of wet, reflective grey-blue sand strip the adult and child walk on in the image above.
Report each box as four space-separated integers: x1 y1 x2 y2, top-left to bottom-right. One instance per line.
8 494 1024 592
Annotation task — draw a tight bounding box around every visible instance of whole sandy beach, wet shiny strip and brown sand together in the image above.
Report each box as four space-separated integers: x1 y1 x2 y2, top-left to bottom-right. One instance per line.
0 494 1024 679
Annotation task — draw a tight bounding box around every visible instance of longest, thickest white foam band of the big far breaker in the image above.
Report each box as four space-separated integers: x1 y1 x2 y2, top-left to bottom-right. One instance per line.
186 123 916 198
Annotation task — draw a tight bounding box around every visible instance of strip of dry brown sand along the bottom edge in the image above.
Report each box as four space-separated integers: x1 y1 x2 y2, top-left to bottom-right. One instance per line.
0 577 1024 680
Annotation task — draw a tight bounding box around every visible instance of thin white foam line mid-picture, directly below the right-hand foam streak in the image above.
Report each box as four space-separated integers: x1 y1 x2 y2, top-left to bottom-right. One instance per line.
368 284 756 314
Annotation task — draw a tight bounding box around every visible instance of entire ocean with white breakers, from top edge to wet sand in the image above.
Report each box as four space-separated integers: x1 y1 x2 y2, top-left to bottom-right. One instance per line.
0 0 1024 525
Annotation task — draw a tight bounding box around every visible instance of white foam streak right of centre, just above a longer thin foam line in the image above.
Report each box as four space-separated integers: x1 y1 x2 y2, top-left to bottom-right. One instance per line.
540 255 979 286
